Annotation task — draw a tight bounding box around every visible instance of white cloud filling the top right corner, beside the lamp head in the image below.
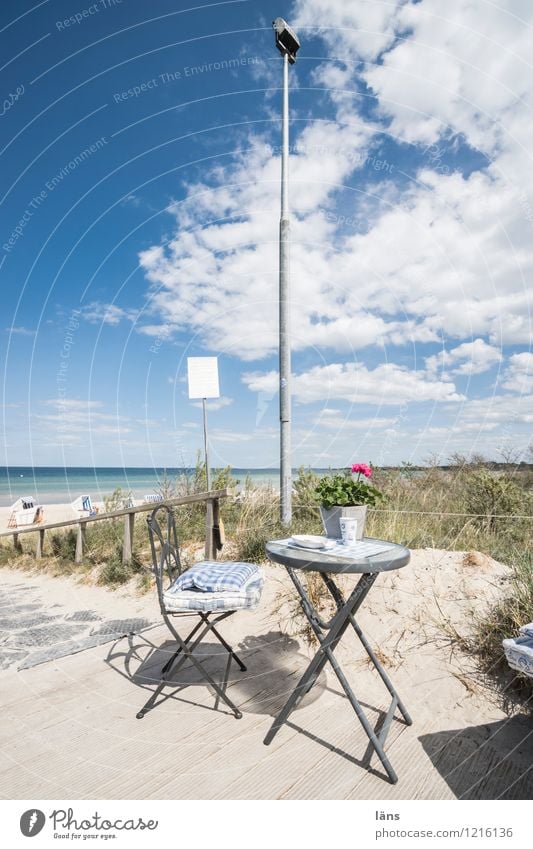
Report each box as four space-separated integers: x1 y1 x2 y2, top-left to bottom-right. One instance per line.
294 0 533 155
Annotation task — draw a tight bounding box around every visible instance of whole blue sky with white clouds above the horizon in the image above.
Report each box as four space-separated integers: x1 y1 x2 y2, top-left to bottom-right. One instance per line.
0 0 533 467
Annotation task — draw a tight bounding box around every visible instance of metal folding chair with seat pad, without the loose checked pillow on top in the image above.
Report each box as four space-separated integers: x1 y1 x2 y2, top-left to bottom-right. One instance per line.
137 506 263 719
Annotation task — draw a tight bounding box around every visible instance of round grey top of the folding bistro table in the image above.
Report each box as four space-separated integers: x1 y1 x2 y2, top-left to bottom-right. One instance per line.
265 537 411 575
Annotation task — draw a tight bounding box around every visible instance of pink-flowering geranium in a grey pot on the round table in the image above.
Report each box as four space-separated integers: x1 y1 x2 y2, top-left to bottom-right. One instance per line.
315 463 384 539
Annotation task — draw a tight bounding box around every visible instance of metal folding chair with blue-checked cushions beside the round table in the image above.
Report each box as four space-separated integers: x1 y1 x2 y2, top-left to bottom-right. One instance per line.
137 506 263 719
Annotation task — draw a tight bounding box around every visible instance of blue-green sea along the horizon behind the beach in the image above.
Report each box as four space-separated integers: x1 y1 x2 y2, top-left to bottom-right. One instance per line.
0 466 326 507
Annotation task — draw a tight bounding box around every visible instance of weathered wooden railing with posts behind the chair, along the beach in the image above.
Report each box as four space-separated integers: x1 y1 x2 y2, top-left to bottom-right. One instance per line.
0 489 231 563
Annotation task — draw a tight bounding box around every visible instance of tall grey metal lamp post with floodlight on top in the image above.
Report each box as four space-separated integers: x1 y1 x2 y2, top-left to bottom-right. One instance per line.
272 18 300 525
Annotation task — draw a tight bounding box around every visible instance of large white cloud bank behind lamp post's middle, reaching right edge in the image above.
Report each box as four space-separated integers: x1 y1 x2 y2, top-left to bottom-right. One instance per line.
140 137 533 360
